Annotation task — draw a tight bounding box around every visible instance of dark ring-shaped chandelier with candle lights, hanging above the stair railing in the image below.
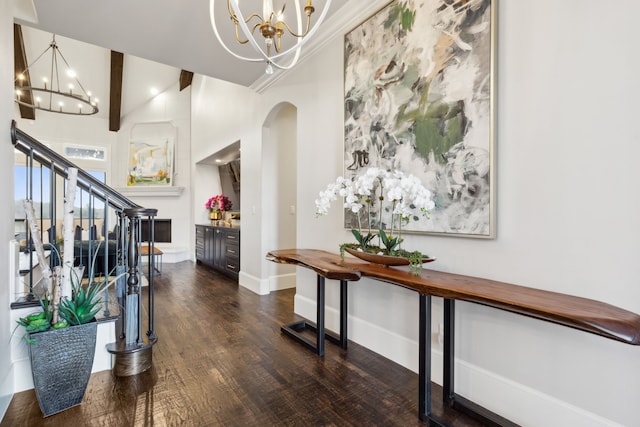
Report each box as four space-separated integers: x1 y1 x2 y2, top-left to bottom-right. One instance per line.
14 34 98 116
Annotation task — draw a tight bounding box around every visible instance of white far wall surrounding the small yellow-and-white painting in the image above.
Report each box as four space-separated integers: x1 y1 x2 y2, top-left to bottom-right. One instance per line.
113 82 193 262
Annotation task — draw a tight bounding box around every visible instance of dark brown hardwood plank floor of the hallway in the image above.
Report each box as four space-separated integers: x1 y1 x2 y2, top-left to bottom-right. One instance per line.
0 262 481 427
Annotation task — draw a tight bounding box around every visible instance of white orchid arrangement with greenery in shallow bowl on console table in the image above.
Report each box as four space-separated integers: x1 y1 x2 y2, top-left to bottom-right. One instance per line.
316 168 435 265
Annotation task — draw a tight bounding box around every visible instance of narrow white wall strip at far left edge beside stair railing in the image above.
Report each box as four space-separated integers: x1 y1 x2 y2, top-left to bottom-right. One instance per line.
0 0 14 419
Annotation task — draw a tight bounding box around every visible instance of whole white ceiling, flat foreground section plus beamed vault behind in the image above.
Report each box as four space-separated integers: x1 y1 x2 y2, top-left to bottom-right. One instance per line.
11 0 351 130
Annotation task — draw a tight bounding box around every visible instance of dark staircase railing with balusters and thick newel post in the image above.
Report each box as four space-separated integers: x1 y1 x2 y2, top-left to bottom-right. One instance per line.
11 121 157 376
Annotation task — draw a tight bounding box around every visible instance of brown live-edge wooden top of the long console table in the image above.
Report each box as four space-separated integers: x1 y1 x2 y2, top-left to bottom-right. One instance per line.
267 249 640 345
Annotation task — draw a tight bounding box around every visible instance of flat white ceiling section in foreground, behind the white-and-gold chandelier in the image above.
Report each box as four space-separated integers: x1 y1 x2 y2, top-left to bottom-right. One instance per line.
17 0 348 86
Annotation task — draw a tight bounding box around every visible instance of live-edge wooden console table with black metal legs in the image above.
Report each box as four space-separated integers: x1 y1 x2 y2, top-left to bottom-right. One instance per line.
267 249 640 426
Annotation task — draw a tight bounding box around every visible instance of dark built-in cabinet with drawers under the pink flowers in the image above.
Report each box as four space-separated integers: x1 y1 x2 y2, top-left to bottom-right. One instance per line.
196 225 240 280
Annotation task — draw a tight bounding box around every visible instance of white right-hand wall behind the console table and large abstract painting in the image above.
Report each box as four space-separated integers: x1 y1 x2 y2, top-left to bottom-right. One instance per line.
189 0 640 426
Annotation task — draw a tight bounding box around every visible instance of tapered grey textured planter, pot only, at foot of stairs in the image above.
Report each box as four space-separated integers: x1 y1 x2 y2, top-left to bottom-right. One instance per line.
27 321 98 417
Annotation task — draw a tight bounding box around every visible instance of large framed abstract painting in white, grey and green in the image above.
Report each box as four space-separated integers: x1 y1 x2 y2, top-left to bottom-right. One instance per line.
344 0 496 238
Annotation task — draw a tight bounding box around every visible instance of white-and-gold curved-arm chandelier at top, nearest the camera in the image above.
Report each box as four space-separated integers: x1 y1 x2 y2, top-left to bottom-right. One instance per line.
209 0 331 74
